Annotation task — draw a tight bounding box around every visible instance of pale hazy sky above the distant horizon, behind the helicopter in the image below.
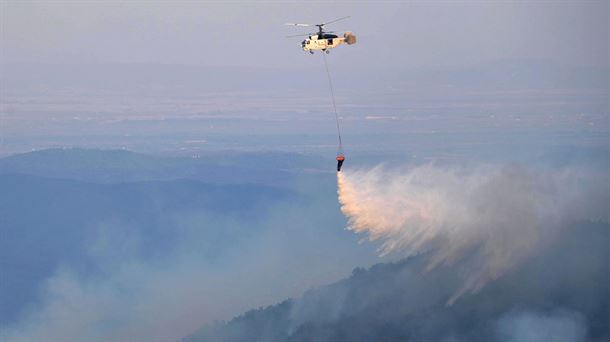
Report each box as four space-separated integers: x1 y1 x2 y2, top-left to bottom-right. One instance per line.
0 0 610 68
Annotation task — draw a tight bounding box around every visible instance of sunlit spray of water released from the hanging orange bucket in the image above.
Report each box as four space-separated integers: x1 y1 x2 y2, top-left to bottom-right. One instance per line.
337 165 608 304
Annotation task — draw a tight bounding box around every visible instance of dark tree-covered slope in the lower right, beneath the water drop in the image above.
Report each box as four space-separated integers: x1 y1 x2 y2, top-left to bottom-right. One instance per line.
185 222 610 342
